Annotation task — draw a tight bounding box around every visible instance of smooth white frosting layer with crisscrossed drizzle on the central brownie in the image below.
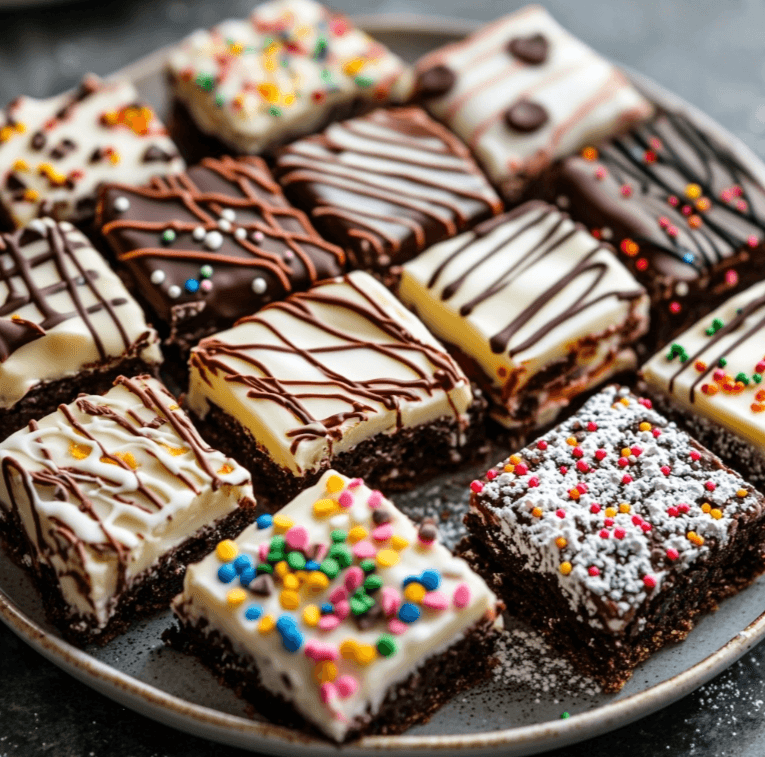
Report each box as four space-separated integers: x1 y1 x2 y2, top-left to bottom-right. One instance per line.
186 271 472 476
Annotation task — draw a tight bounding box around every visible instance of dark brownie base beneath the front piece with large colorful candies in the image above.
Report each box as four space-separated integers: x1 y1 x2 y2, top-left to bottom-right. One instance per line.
162 608 499 742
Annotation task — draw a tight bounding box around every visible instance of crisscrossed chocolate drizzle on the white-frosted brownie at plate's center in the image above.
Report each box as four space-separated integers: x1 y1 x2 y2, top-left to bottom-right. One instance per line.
191 276 465 454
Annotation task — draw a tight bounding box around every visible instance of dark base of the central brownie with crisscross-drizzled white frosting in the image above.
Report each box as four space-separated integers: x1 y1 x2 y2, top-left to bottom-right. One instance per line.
188 394 488 512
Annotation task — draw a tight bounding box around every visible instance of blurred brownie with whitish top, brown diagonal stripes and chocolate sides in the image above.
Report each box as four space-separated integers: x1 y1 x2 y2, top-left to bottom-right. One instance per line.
276 108 502 274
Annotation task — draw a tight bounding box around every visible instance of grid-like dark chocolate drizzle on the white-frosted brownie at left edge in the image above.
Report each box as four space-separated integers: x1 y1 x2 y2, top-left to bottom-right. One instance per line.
0 221 131 361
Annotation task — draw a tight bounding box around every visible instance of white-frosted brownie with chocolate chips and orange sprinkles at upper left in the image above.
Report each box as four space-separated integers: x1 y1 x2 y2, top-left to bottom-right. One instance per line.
0 75 185 227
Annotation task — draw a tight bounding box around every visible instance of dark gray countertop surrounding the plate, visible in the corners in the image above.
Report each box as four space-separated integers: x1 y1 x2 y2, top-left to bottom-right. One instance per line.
0 0 765 757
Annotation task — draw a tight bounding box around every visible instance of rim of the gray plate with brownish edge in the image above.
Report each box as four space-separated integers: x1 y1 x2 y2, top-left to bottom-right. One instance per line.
0 12 765 757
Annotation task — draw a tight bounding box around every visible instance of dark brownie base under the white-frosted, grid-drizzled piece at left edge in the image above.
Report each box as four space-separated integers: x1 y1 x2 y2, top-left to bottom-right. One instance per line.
0 352 159 439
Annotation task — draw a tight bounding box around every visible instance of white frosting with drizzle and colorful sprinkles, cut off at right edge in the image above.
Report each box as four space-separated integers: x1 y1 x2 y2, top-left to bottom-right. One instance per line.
641 282 765 454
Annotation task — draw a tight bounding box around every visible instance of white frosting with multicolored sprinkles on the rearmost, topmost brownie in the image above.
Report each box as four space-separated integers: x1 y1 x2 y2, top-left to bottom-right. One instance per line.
168 0 412 153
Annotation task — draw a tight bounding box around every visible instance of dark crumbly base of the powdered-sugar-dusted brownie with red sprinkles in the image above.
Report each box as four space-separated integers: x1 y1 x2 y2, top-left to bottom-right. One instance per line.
457 496 765 693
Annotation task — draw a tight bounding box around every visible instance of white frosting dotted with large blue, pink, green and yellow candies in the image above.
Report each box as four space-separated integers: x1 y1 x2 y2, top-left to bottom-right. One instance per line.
173 471 501 741
